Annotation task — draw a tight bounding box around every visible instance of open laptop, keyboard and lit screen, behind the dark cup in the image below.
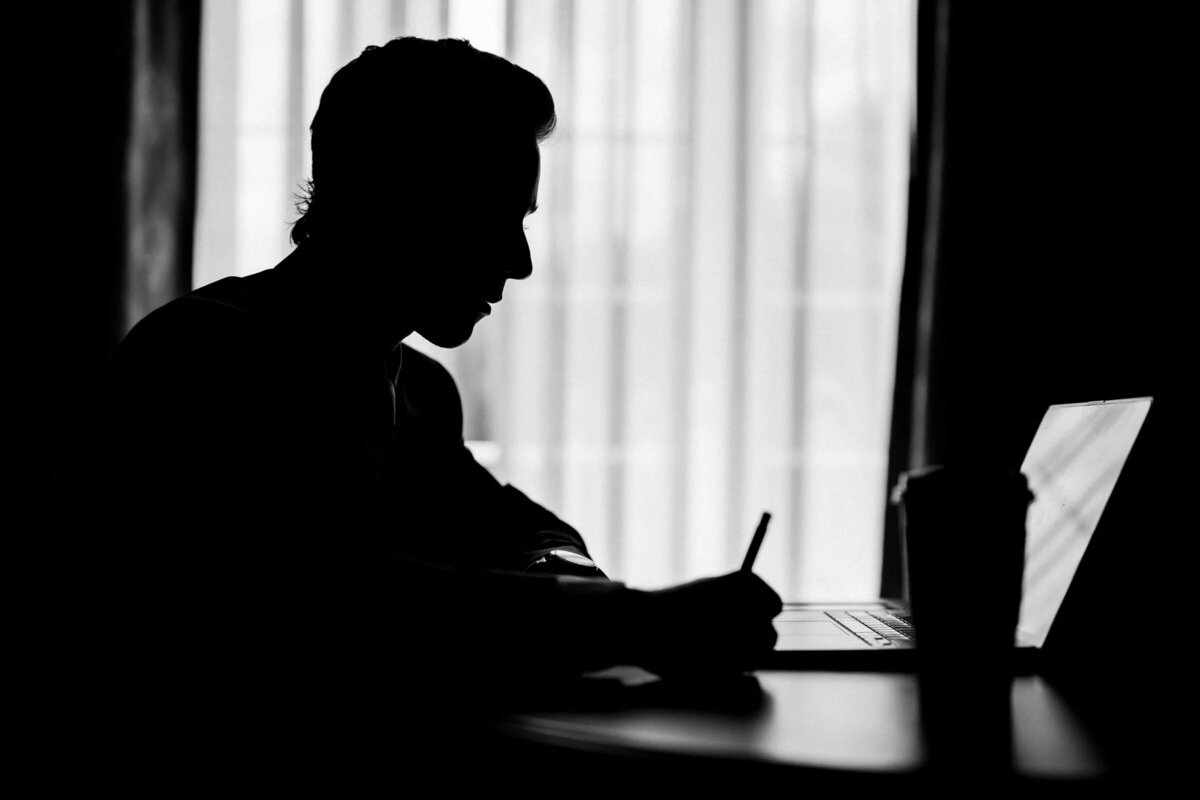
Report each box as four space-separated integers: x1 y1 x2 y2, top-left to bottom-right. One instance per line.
763 397 1153 669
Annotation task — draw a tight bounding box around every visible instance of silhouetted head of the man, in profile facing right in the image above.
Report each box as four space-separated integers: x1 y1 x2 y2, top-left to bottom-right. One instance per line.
292 37 556 347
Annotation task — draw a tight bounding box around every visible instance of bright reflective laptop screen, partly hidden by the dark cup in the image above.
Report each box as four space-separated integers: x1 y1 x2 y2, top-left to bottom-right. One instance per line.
1016 397 1151 648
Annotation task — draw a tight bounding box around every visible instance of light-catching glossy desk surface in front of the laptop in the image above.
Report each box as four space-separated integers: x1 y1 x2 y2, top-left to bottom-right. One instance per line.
500 672 1105 783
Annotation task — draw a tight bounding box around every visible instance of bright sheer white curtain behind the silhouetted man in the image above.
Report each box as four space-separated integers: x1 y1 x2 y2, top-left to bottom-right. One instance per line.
196 0 914 600
